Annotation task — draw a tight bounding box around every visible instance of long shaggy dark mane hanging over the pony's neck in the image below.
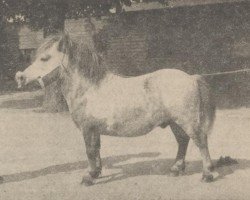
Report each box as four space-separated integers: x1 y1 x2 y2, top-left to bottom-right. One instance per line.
58 35 107 84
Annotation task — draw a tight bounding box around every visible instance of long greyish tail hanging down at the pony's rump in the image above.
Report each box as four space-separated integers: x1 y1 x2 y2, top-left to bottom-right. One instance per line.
196 75 216 135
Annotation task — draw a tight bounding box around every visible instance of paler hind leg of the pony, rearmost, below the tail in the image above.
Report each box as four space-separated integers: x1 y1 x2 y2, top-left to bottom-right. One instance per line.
193 134 214 182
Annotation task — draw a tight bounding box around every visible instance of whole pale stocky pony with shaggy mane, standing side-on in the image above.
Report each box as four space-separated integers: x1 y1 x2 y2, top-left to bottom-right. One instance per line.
16 34 215 185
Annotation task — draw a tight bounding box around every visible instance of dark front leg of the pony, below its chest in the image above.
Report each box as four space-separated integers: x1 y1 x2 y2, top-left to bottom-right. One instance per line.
82 132 102 185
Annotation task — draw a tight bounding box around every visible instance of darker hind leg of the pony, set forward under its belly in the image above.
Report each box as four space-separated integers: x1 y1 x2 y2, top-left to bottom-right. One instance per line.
170 122 190 176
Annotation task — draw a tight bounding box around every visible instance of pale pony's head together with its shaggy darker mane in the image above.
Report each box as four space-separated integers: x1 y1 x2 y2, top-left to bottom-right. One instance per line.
15 34 106 88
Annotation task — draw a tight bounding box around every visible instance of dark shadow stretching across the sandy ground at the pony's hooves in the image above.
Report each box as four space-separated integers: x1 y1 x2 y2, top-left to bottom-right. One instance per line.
0 152 250 184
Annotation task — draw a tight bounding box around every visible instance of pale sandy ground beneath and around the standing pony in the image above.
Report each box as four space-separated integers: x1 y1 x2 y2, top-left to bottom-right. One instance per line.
0 92 250 200
